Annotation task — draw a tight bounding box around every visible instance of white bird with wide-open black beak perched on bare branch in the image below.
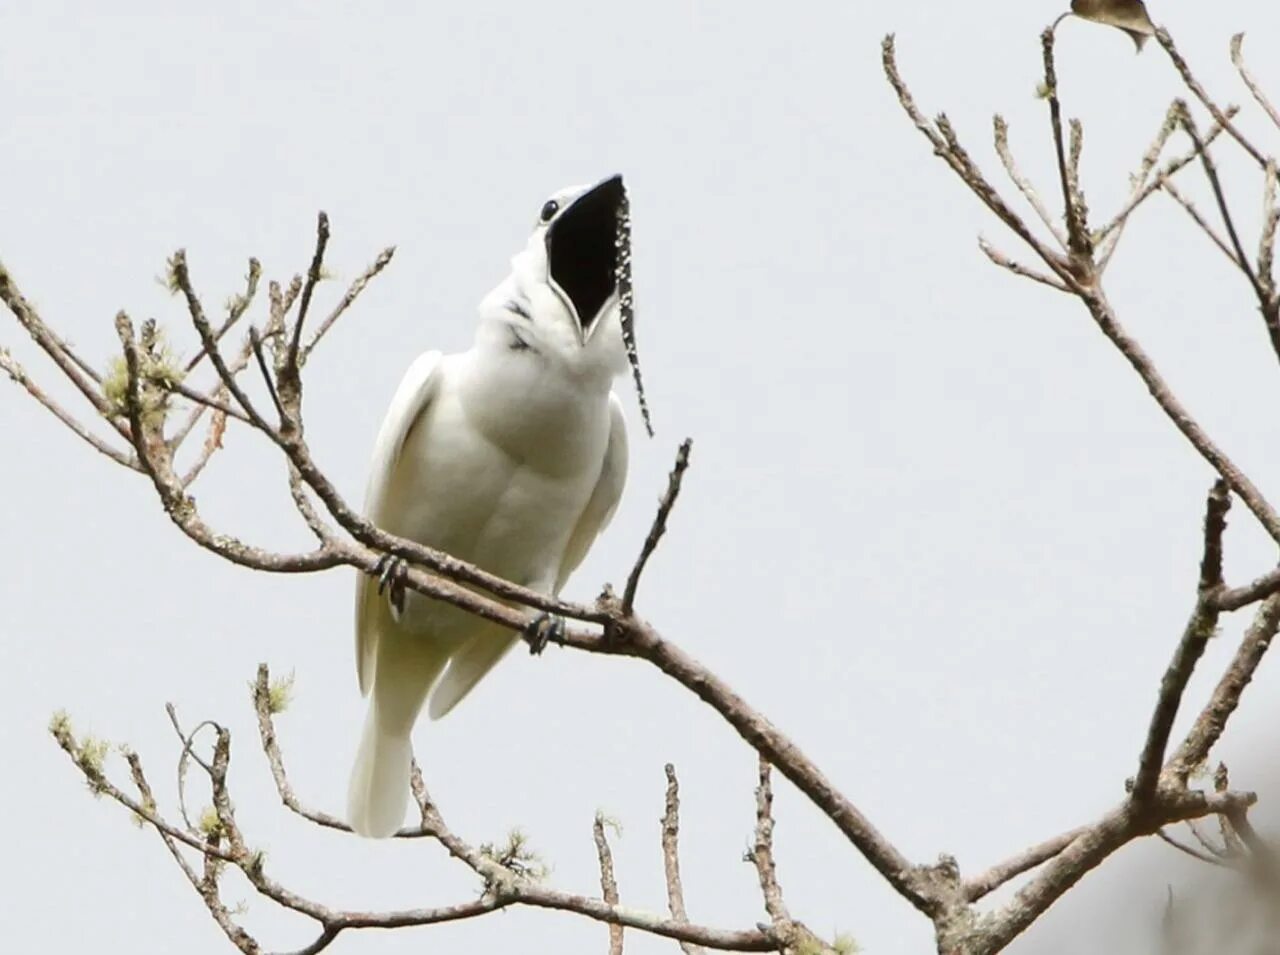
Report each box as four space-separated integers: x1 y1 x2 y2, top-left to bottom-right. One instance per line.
348 175 652 837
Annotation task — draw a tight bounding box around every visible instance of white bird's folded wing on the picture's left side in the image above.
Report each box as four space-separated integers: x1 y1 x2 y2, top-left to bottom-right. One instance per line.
356 352 440 694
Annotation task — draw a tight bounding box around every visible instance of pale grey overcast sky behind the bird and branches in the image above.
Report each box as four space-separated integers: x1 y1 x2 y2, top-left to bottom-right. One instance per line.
0 0 1280 955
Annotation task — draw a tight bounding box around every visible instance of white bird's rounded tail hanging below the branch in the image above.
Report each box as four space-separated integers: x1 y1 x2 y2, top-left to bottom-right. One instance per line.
347 700 413 839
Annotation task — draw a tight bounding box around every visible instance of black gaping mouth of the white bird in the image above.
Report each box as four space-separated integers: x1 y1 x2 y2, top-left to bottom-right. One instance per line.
547 175 626 338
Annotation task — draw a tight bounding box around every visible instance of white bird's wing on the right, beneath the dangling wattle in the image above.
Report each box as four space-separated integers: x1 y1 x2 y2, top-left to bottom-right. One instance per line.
428 394 627 719
